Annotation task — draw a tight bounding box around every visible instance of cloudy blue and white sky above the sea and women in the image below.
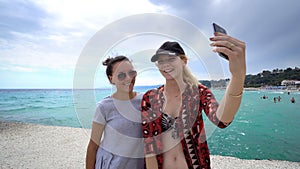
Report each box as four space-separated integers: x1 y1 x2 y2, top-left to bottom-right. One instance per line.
0 0 300 88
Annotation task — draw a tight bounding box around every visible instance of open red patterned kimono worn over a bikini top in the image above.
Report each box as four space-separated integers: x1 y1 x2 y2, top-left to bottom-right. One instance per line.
142 84 229 169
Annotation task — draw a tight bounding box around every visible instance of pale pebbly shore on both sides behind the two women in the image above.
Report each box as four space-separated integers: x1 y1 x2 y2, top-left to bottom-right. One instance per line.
0 121 300 169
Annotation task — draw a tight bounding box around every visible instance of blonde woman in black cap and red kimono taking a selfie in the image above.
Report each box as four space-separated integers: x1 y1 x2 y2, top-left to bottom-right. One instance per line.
142 33 246 169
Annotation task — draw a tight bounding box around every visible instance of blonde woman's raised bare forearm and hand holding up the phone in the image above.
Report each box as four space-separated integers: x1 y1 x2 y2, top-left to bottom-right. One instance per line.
210 33 246 123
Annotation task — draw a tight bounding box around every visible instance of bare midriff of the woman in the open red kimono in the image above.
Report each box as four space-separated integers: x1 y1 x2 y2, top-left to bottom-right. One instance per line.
163 131 188 169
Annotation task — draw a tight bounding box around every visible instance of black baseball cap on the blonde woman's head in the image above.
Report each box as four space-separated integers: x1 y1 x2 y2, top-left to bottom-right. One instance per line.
151 41 185 62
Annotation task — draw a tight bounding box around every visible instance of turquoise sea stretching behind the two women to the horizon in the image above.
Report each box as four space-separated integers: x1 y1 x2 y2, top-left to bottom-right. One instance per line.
0 87 300 162
